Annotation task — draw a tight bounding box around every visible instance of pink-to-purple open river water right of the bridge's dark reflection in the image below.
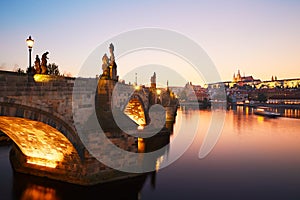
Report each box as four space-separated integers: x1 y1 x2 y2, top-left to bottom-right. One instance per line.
142 106 300 200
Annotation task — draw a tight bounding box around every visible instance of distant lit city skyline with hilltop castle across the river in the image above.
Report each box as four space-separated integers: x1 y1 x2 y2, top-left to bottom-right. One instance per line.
172 70 300 104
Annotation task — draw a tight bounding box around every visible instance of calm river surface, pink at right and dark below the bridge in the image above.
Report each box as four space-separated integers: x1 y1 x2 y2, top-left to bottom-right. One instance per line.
0 107 300 200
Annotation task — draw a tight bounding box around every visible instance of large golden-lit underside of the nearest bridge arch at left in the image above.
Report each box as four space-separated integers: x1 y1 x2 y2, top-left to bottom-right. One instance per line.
0 116 77 168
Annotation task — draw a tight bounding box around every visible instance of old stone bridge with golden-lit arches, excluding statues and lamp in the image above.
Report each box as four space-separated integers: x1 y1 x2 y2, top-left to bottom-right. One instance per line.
0 71 176 185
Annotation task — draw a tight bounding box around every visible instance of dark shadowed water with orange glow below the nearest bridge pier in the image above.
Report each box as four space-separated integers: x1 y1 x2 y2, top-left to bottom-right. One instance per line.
0 145 149 200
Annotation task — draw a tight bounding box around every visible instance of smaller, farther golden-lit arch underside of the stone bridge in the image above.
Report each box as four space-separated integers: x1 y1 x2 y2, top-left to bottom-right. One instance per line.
124 98 146 126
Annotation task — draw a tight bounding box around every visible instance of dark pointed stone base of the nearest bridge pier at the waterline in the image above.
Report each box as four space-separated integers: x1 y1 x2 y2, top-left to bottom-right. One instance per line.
10 144 139 186
